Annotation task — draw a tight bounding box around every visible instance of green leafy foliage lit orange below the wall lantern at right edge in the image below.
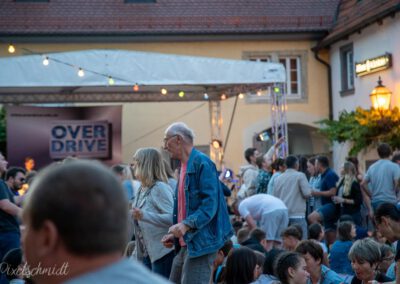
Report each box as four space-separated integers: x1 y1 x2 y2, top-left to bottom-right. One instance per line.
318 107 400 155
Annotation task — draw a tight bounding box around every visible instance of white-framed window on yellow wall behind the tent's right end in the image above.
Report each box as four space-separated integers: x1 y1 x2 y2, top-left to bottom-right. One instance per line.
243 51 307 102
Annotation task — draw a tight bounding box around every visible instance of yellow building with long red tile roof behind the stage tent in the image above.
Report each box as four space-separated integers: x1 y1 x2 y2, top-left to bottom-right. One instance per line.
0 0 338 171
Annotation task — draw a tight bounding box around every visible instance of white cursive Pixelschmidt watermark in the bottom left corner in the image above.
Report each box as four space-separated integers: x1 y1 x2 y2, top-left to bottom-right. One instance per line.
0 262 69 277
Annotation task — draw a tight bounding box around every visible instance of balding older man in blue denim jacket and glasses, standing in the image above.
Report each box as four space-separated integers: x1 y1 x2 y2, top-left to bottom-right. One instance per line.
162 122 232 284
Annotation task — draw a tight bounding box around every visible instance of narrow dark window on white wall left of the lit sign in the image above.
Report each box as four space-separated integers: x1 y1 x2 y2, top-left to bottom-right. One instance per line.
340 44 354 96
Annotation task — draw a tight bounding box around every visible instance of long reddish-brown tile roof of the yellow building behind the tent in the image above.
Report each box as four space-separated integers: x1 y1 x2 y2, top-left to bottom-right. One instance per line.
0 0 339 36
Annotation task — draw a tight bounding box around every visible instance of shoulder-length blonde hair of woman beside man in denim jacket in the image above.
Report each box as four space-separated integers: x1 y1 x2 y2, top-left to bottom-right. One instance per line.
133 148 168 187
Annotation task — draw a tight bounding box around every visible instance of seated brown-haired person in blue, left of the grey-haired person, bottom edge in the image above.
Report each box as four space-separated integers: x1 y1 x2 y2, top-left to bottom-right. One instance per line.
296 240 343 284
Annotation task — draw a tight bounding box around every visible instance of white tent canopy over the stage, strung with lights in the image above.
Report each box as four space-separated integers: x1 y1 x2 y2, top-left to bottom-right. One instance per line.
0 50 285 102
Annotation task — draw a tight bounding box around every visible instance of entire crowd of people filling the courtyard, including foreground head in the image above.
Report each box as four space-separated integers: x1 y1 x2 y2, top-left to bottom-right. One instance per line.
0 122 400 284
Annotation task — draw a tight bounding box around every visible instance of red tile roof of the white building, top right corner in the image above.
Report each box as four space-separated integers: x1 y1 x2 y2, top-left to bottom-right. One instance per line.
316 0 400 49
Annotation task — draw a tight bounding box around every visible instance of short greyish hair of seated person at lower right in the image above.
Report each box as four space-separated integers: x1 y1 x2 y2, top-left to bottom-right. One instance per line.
349 238 381 266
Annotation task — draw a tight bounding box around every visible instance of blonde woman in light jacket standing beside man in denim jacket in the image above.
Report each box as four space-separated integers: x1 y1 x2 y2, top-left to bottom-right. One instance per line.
132 148 174 278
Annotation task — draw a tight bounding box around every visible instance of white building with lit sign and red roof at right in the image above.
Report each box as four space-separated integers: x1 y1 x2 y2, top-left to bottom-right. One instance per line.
317 0 400 171
